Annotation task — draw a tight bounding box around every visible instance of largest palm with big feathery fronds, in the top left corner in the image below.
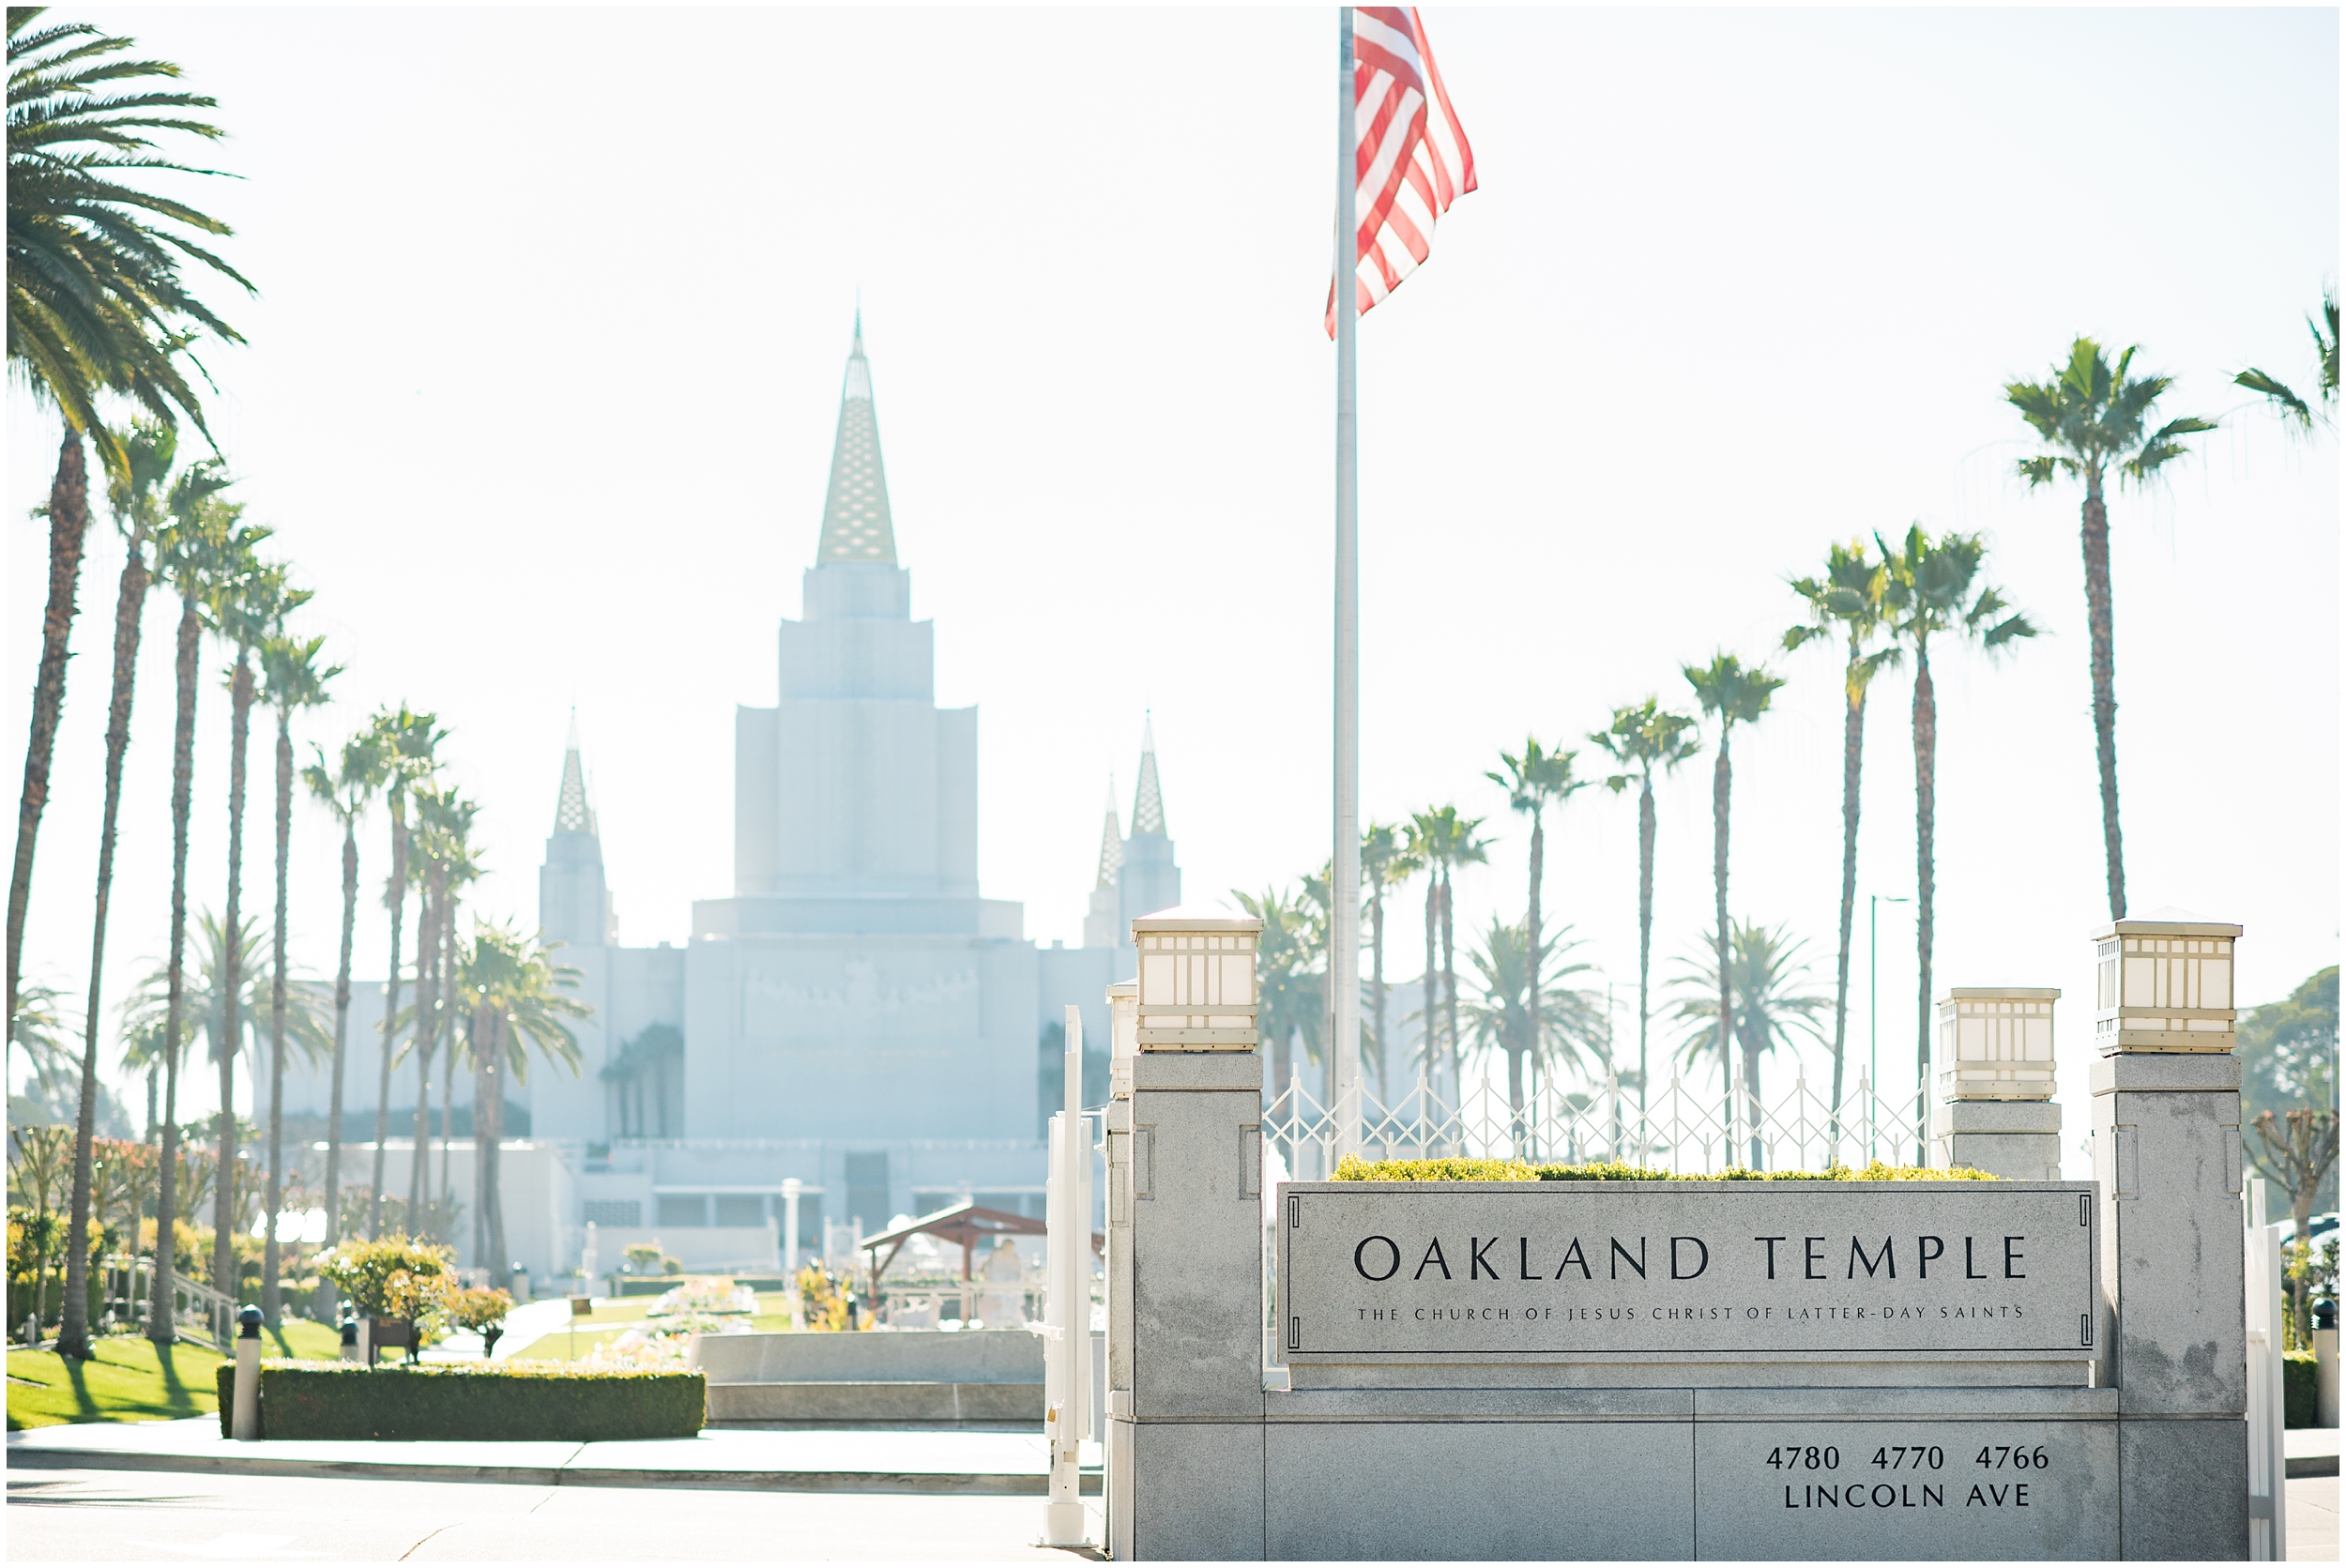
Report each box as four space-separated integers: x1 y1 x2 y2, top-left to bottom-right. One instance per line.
8 15 251 1042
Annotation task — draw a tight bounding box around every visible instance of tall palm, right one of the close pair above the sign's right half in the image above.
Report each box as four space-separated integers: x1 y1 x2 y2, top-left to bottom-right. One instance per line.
1875 524 2036 1165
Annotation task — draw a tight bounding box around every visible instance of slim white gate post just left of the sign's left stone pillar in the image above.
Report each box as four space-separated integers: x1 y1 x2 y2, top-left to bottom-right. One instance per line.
1042 1005 1091 1546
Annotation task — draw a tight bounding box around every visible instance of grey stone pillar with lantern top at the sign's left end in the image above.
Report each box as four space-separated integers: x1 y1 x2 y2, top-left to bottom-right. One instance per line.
1107 911 1262 1560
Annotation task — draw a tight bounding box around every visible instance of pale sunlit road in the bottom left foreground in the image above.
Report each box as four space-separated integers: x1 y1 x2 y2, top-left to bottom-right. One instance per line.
8 1469 1098 1563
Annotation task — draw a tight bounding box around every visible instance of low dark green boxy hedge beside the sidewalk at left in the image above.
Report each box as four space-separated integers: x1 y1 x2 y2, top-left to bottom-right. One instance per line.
219 1362 708 1443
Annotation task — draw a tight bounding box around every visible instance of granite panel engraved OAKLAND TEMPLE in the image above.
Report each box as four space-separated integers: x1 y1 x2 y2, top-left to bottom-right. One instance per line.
1279 1180 2100 1362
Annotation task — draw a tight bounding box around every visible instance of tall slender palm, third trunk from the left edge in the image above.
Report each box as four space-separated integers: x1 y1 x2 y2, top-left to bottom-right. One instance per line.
148 488 244 1345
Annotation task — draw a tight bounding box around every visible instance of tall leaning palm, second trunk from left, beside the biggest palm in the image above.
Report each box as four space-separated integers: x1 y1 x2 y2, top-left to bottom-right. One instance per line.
59 418 213 1359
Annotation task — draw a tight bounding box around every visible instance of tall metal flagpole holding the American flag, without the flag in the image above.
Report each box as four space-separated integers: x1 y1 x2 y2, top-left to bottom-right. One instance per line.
1328 5 1361 1160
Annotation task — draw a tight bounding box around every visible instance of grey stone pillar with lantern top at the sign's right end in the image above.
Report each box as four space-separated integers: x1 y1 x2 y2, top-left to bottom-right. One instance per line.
2093 921 2247 1560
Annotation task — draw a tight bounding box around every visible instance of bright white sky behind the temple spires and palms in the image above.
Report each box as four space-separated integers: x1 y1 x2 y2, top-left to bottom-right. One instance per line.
0 9 2339 1166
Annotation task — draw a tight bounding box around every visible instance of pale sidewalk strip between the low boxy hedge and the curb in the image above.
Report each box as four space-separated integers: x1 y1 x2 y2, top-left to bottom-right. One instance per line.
8 1415 1101 1498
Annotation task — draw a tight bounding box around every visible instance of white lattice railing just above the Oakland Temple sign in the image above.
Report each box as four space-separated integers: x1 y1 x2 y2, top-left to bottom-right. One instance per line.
1262 1068 1928 1180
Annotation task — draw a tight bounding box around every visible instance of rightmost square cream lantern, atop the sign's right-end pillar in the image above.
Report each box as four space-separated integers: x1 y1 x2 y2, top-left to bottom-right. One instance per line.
2093 921 2241 1057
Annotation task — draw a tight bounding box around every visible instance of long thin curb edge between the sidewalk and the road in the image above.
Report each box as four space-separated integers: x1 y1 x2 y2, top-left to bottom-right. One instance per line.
8 1446 1101 1498
